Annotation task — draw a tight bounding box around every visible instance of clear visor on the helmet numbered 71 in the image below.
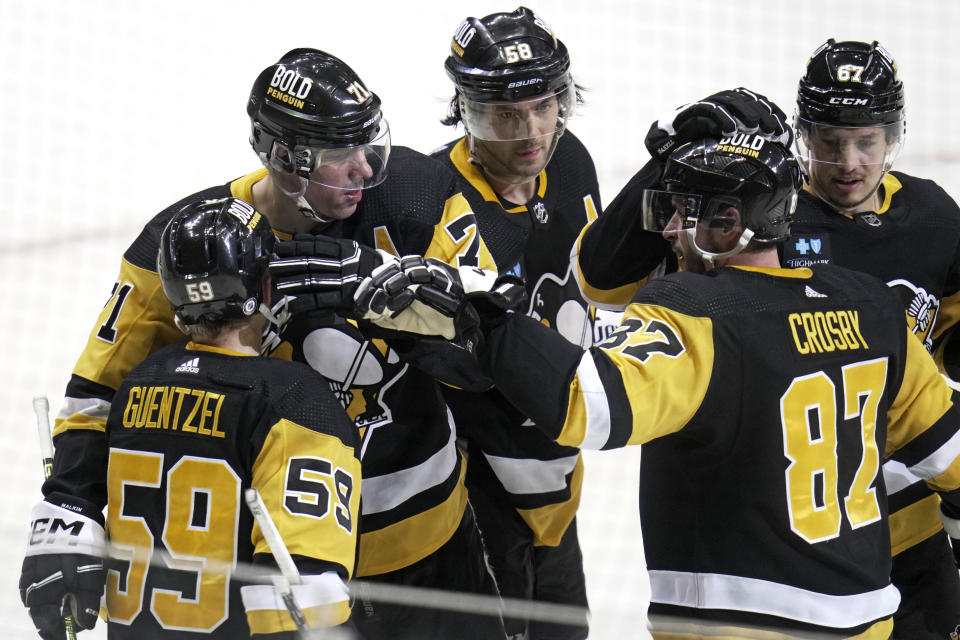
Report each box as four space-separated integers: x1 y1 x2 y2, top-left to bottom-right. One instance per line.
280 120 390 191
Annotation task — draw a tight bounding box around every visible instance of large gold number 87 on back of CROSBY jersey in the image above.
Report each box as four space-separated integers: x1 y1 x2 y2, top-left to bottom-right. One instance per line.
780 358 887 543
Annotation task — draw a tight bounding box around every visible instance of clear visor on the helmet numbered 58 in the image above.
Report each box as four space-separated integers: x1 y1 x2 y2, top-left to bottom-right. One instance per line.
460 84 576 141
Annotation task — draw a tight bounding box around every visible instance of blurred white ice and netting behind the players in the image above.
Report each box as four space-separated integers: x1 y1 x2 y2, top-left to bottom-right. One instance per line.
0 0 960 640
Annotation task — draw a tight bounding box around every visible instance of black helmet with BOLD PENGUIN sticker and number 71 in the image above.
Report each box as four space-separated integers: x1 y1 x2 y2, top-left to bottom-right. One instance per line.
247 48 390 189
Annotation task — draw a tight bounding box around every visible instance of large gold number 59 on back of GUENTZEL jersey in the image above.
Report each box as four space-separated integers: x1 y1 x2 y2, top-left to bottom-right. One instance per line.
106 449 240 632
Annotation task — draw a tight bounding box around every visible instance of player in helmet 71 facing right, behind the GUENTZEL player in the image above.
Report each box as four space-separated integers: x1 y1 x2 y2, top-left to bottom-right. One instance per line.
49 49 504 638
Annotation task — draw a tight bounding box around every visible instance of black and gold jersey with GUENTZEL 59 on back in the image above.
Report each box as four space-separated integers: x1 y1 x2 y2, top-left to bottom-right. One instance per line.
44 342 361 638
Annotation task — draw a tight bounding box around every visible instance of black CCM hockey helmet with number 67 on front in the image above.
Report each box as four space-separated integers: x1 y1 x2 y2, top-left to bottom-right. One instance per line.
797 38 904 127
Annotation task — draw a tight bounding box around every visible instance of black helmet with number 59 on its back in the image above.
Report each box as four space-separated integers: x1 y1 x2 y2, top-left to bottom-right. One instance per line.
157 198 276 325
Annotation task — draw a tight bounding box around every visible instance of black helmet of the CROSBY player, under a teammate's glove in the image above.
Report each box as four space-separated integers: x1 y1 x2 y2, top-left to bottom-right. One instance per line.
642 134 801 250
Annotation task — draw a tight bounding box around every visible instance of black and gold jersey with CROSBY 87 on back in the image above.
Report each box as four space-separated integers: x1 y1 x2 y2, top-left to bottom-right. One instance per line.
484 265 960 638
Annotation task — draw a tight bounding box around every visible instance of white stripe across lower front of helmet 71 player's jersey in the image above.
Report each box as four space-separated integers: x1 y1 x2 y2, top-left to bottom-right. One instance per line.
360 409 458 515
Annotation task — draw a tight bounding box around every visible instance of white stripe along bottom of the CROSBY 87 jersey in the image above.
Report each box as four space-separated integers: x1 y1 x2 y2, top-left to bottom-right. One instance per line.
649 570 900 629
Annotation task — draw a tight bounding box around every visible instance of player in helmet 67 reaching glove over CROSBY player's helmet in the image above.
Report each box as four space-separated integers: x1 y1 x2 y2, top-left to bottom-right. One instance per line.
578 40 960 640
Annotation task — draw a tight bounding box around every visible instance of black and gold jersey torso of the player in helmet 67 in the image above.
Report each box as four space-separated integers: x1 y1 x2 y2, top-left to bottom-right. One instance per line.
782 172 960 554
